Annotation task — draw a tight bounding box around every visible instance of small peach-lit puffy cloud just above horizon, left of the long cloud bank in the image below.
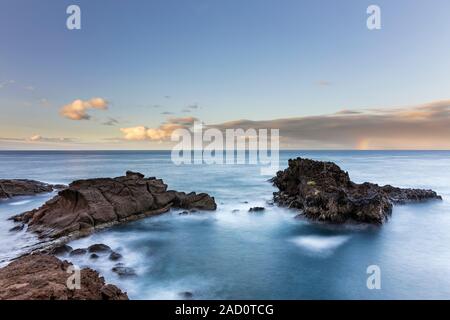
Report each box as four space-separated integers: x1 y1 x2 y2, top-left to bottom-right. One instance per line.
120 117 198 141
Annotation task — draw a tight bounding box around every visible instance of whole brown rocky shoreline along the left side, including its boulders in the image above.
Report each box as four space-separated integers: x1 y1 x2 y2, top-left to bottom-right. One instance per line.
0 171 217 300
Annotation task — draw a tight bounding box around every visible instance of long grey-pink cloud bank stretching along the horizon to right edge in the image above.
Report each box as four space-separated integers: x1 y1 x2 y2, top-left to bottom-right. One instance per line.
212 100 450 149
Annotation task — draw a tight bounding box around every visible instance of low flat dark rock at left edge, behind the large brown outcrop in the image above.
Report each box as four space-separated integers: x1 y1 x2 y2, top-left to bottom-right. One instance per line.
0 179 64 199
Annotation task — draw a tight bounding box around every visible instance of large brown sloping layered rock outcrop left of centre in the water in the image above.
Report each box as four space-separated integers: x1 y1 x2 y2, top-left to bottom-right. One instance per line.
12 171 217 238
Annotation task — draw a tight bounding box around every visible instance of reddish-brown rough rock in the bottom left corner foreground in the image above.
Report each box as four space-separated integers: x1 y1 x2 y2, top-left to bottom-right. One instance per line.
0 254 128 300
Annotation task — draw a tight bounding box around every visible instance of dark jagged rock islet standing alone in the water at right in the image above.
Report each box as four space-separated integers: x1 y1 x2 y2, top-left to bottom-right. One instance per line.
272 158 442 224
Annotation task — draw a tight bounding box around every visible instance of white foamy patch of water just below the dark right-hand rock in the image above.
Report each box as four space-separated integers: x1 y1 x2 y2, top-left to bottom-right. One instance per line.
291 235 350 254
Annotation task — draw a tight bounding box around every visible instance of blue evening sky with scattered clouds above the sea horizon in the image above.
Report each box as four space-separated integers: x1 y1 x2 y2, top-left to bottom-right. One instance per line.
0 0 450 149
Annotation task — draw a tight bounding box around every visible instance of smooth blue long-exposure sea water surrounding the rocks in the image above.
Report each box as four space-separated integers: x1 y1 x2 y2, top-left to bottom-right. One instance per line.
0 151 450 299
